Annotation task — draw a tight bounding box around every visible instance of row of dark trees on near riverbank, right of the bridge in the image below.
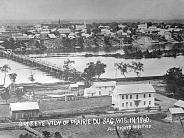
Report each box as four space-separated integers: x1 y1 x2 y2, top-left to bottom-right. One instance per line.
60 59 144 86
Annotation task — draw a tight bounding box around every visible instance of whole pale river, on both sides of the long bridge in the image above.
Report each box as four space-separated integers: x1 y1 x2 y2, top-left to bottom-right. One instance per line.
0 45 184 84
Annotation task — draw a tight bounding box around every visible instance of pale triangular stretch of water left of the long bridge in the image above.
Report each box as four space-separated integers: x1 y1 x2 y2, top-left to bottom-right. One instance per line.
0 58 60 85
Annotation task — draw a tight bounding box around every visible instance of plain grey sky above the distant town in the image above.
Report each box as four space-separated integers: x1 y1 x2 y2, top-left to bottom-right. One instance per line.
0 0 184 20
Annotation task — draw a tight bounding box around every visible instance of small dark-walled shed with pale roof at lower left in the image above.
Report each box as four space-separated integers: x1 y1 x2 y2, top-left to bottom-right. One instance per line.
9 102 39 120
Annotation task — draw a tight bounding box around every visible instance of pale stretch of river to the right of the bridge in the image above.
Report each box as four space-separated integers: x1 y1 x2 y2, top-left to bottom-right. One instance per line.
39 56 184 78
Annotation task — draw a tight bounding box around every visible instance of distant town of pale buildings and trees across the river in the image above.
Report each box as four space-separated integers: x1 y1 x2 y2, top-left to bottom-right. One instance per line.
0 19 184 58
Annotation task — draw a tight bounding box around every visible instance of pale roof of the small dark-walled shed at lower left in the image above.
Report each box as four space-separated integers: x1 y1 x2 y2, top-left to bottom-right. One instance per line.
9 102 39 111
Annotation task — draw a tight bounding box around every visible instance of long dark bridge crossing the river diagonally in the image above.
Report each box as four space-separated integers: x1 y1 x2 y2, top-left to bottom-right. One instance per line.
0 50 78 79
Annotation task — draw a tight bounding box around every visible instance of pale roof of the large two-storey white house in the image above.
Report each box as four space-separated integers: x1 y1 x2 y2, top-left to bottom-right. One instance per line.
114 84 155 94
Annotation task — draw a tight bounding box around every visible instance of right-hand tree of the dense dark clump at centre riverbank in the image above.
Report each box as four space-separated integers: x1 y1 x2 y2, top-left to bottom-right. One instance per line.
95 61 107 79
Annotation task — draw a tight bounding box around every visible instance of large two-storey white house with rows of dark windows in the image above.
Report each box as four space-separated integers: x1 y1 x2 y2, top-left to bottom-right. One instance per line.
112 84 155 110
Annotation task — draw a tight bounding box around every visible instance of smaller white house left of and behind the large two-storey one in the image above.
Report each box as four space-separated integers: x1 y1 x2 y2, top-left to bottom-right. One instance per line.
84 81 116 97
